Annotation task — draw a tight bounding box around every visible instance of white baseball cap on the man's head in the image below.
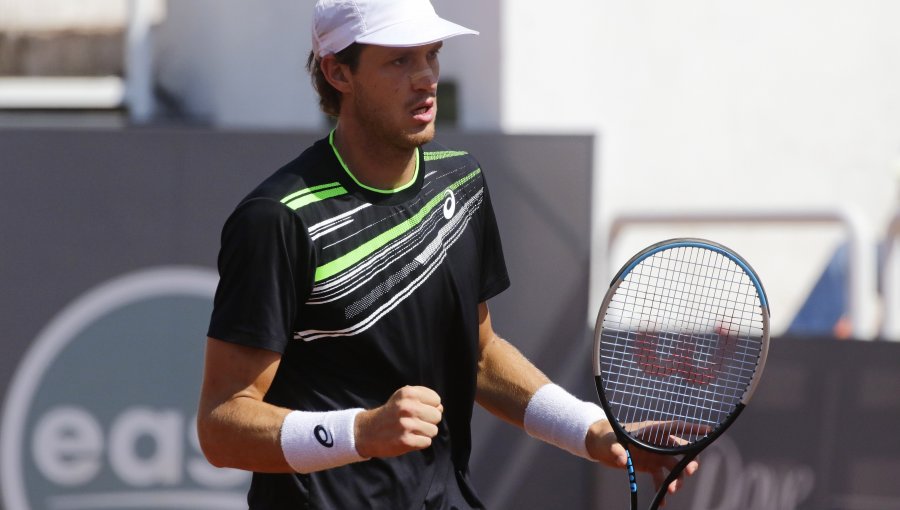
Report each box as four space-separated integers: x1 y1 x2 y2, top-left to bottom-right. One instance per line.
313 0 478 57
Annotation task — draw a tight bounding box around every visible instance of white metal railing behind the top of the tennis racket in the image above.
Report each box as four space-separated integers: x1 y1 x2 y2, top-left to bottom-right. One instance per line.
601 209 876 340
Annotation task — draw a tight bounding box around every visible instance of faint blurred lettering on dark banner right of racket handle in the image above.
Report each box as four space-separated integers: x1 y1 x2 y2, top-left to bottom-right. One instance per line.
691 436 815 510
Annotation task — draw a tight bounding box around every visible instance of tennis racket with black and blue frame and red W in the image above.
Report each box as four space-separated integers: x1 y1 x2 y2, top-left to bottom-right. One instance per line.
593 239 769 510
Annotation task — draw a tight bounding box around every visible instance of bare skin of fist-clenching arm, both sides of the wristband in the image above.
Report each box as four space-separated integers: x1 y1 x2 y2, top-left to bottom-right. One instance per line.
197 338 444 473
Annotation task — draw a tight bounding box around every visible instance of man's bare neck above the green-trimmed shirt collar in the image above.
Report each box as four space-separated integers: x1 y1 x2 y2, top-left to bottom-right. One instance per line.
333 122 418 191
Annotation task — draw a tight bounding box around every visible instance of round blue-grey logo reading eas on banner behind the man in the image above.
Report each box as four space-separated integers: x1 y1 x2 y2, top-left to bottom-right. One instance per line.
0 267 249 510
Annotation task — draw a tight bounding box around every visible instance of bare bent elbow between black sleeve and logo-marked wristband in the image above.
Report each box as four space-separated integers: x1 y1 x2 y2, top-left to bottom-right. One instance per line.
197 338 293 473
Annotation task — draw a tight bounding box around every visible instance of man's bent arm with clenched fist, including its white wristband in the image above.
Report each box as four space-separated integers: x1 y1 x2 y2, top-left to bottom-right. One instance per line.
197 338 443 473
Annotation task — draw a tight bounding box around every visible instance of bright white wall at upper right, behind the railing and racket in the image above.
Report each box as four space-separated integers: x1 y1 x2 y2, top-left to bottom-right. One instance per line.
502 0 900 336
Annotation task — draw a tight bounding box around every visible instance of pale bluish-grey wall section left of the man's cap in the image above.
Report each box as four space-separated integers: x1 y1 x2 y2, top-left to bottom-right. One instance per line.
156 0 323 129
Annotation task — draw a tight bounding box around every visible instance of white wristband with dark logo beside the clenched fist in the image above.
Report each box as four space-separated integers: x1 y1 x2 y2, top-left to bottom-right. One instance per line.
281 409 366 473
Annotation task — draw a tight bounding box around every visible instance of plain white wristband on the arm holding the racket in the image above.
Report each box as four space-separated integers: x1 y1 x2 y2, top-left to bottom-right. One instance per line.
525 384 606 460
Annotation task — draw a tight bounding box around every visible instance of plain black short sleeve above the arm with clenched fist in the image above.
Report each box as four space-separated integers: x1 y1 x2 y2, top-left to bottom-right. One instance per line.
208 198 315 353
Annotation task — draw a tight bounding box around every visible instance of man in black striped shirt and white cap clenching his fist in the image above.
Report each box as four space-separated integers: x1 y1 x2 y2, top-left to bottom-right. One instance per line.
198 0 696 509
